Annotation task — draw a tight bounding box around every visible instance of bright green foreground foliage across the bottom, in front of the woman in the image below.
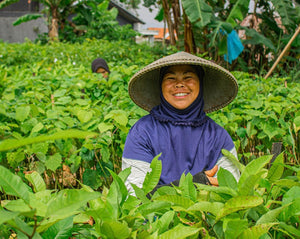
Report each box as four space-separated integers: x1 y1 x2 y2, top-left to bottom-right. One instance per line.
0 151 300 238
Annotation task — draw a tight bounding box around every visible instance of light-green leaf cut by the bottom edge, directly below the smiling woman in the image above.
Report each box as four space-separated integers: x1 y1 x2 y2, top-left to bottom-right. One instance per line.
158 224 201 239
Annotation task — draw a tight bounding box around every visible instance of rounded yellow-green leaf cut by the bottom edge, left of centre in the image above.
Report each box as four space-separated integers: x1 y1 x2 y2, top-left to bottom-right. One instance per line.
100 221 130 239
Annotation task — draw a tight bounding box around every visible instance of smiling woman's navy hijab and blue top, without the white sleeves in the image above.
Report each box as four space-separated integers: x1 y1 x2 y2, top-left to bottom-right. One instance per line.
123 65 234 184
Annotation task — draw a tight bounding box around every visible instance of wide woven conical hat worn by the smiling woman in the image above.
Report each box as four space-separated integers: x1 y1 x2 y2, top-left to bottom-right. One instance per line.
128 52 238 113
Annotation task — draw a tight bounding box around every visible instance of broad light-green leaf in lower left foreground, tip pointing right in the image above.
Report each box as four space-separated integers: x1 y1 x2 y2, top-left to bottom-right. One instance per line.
46 189 101 221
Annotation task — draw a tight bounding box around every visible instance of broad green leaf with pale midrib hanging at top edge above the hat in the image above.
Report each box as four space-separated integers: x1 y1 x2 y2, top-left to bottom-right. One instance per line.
181 0 213 28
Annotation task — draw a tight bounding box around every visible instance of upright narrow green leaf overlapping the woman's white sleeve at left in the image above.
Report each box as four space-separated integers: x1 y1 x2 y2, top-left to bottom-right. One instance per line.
143 154 162 194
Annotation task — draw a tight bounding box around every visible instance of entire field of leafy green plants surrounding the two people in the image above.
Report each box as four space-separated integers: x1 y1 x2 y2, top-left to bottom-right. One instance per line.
0 39 300 238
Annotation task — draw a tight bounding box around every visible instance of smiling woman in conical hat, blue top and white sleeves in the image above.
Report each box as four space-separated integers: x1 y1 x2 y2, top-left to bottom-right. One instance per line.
122 52 239 193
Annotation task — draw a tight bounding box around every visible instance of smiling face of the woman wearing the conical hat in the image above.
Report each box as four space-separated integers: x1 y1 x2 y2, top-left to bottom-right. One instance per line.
161 65 200 110
